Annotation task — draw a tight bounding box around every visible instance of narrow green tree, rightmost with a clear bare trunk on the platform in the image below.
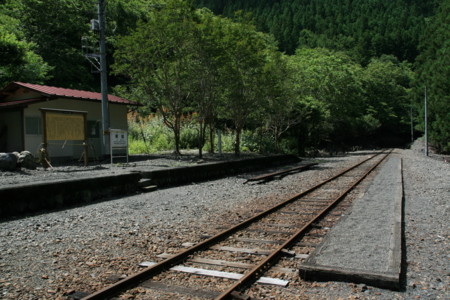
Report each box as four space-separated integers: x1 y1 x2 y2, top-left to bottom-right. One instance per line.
221 14 276 155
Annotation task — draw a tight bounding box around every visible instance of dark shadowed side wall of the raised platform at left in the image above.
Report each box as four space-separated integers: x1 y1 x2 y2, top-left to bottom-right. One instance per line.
0 155 299 218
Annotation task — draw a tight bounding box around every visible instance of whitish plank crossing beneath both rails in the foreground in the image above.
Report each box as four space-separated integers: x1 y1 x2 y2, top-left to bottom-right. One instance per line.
139 262 289 287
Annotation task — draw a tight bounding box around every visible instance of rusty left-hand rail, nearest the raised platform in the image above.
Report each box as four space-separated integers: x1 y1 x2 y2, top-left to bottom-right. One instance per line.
82 152 383 300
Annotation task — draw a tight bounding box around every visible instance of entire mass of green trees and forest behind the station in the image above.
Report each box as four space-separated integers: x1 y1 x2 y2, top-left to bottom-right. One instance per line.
0 0 450 156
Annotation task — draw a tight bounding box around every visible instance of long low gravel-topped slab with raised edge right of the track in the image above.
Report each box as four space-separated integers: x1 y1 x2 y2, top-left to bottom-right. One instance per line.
300 156 403 290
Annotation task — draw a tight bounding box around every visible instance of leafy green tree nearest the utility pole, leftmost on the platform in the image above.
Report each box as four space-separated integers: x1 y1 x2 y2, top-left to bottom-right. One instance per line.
113 0 196 154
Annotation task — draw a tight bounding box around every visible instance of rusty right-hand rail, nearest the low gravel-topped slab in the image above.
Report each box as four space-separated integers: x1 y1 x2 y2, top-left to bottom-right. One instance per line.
216 151 392 300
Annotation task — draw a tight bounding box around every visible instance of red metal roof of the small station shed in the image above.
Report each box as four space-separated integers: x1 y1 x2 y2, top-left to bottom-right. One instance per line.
3 81 141 106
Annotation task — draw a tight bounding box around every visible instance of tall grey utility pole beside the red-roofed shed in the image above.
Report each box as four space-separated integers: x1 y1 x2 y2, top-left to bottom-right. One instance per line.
98 0 110 154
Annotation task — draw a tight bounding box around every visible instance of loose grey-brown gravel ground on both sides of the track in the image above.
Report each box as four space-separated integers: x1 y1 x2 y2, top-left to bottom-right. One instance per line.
0 144 450 299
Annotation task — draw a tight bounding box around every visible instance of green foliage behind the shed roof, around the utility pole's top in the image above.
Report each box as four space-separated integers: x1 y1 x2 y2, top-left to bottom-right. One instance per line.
0 0 162 90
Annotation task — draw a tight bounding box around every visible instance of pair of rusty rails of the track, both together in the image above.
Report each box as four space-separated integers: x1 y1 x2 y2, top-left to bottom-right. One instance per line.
83 152 390 300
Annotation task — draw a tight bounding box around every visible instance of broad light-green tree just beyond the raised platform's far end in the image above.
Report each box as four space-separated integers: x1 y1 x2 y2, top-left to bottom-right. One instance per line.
291 48 364 147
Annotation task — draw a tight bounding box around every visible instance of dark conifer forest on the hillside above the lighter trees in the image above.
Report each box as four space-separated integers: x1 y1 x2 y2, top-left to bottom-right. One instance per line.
196 0 435 63
